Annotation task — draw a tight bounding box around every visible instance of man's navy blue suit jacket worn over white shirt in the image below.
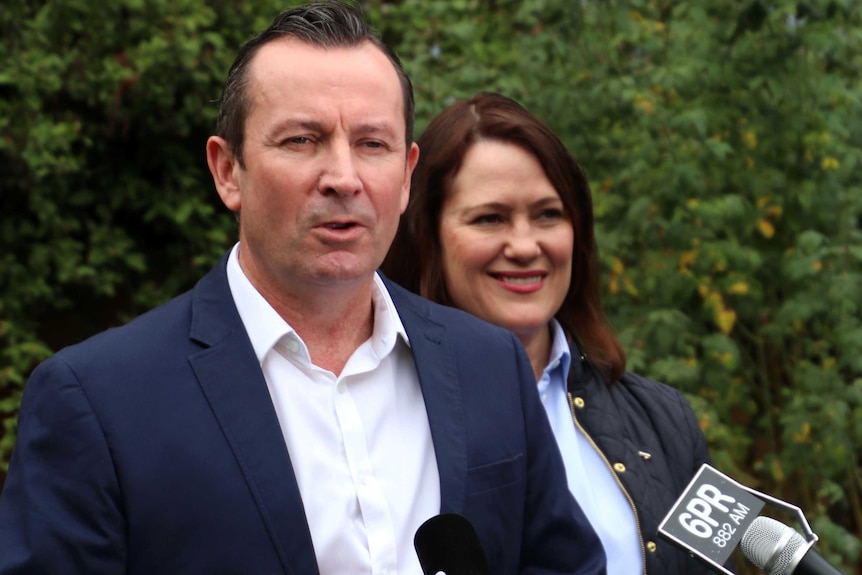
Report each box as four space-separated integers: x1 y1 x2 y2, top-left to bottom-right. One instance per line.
0 258 604 575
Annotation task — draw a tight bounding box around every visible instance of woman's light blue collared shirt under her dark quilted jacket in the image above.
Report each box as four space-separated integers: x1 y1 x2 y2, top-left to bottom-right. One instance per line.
539 320 644 575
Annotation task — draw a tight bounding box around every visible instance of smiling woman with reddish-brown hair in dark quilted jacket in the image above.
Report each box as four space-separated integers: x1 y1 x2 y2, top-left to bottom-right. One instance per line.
383 93 728 575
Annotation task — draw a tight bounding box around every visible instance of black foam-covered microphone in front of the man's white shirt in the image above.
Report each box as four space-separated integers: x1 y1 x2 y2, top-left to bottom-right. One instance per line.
413 513 491 575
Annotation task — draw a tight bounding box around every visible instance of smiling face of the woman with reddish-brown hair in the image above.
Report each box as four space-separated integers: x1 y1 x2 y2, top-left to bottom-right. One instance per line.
440 140 574 339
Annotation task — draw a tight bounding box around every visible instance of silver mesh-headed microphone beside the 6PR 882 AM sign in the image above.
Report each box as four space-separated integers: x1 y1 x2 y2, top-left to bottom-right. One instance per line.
739 517 841 575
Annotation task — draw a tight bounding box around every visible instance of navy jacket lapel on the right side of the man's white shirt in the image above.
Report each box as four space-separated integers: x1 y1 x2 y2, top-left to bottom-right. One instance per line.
386 280 467 513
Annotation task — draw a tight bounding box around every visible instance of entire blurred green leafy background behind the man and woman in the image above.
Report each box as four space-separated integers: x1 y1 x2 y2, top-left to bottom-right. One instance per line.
0 0 862 573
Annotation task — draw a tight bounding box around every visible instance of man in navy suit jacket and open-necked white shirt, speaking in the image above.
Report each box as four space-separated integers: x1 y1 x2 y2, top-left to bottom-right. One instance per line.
0 1 604 575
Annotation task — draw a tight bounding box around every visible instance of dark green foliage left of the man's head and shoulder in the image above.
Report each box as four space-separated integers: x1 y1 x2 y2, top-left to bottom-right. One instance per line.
0 0 286 469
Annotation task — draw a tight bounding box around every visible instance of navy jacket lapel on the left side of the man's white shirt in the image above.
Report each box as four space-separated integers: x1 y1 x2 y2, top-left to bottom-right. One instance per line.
189 258 318 575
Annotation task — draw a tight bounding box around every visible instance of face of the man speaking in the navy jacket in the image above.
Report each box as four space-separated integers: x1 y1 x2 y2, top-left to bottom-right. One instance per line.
208 38 418 297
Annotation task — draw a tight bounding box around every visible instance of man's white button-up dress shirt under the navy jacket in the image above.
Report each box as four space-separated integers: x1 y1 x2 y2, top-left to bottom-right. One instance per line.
227 244 440 575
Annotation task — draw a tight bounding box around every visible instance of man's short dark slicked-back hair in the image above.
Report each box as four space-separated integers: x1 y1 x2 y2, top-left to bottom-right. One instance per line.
216 0 415 168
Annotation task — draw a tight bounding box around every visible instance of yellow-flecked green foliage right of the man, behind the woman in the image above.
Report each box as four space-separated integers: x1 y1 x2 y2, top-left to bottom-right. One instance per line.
381 0 862 571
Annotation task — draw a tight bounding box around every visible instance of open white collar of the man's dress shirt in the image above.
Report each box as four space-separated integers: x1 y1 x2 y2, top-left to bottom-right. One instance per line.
227 242 410 363
